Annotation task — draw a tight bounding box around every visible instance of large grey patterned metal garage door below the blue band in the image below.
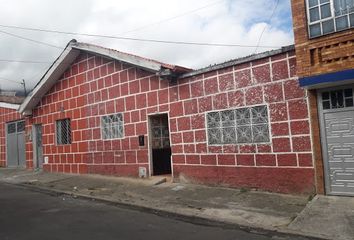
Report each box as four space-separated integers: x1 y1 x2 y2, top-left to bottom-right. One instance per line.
320 87 354 196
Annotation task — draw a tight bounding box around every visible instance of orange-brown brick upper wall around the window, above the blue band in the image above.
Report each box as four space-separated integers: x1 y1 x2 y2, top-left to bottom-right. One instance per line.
291 0 354 77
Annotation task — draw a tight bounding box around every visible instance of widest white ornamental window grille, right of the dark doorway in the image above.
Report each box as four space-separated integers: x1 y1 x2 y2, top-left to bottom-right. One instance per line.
207 106 270 145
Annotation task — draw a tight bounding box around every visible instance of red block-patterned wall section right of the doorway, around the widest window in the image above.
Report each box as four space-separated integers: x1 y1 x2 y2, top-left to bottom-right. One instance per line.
170 52 314 192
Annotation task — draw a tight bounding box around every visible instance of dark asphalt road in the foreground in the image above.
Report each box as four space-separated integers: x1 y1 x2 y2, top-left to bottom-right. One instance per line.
0 183 312 240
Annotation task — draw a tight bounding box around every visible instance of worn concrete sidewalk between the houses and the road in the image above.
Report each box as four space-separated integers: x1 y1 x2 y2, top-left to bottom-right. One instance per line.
0 169 354 240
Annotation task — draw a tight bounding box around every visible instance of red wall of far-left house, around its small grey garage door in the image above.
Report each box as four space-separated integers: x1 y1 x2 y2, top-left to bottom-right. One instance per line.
0 107 21 167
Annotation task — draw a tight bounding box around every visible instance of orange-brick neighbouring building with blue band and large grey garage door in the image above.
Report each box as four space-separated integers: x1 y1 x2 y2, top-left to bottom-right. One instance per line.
292 0 354 196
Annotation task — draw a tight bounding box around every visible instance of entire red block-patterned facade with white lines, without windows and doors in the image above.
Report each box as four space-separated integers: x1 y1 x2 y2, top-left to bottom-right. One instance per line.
23 49 314 195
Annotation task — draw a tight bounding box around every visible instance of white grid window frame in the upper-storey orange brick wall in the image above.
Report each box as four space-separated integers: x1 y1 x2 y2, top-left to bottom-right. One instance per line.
305 0 354 39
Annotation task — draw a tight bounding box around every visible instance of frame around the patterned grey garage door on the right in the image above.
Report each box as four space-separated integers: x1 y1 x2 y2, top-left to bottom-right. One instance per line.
316 84 354 196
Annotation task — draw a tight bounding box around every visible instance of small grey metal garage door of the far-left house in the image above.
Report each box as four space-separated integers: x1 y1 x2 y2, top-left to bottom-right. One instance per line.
6 121 26 167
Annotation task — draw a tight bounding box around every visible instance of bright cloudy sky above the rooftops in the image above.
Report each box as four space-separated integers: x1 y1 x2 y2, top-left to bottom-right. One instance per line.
0 0 294 91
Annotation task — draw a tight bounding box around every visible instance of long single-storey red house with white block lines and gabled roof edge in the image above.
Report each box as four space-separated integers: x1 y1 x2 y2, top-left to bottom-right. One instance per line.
0 41 315 193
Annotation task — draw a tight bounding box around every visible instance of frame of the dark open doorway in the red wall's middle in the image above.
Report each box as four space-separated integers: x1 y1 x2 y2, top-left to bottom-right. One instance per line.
147 112 174 179
